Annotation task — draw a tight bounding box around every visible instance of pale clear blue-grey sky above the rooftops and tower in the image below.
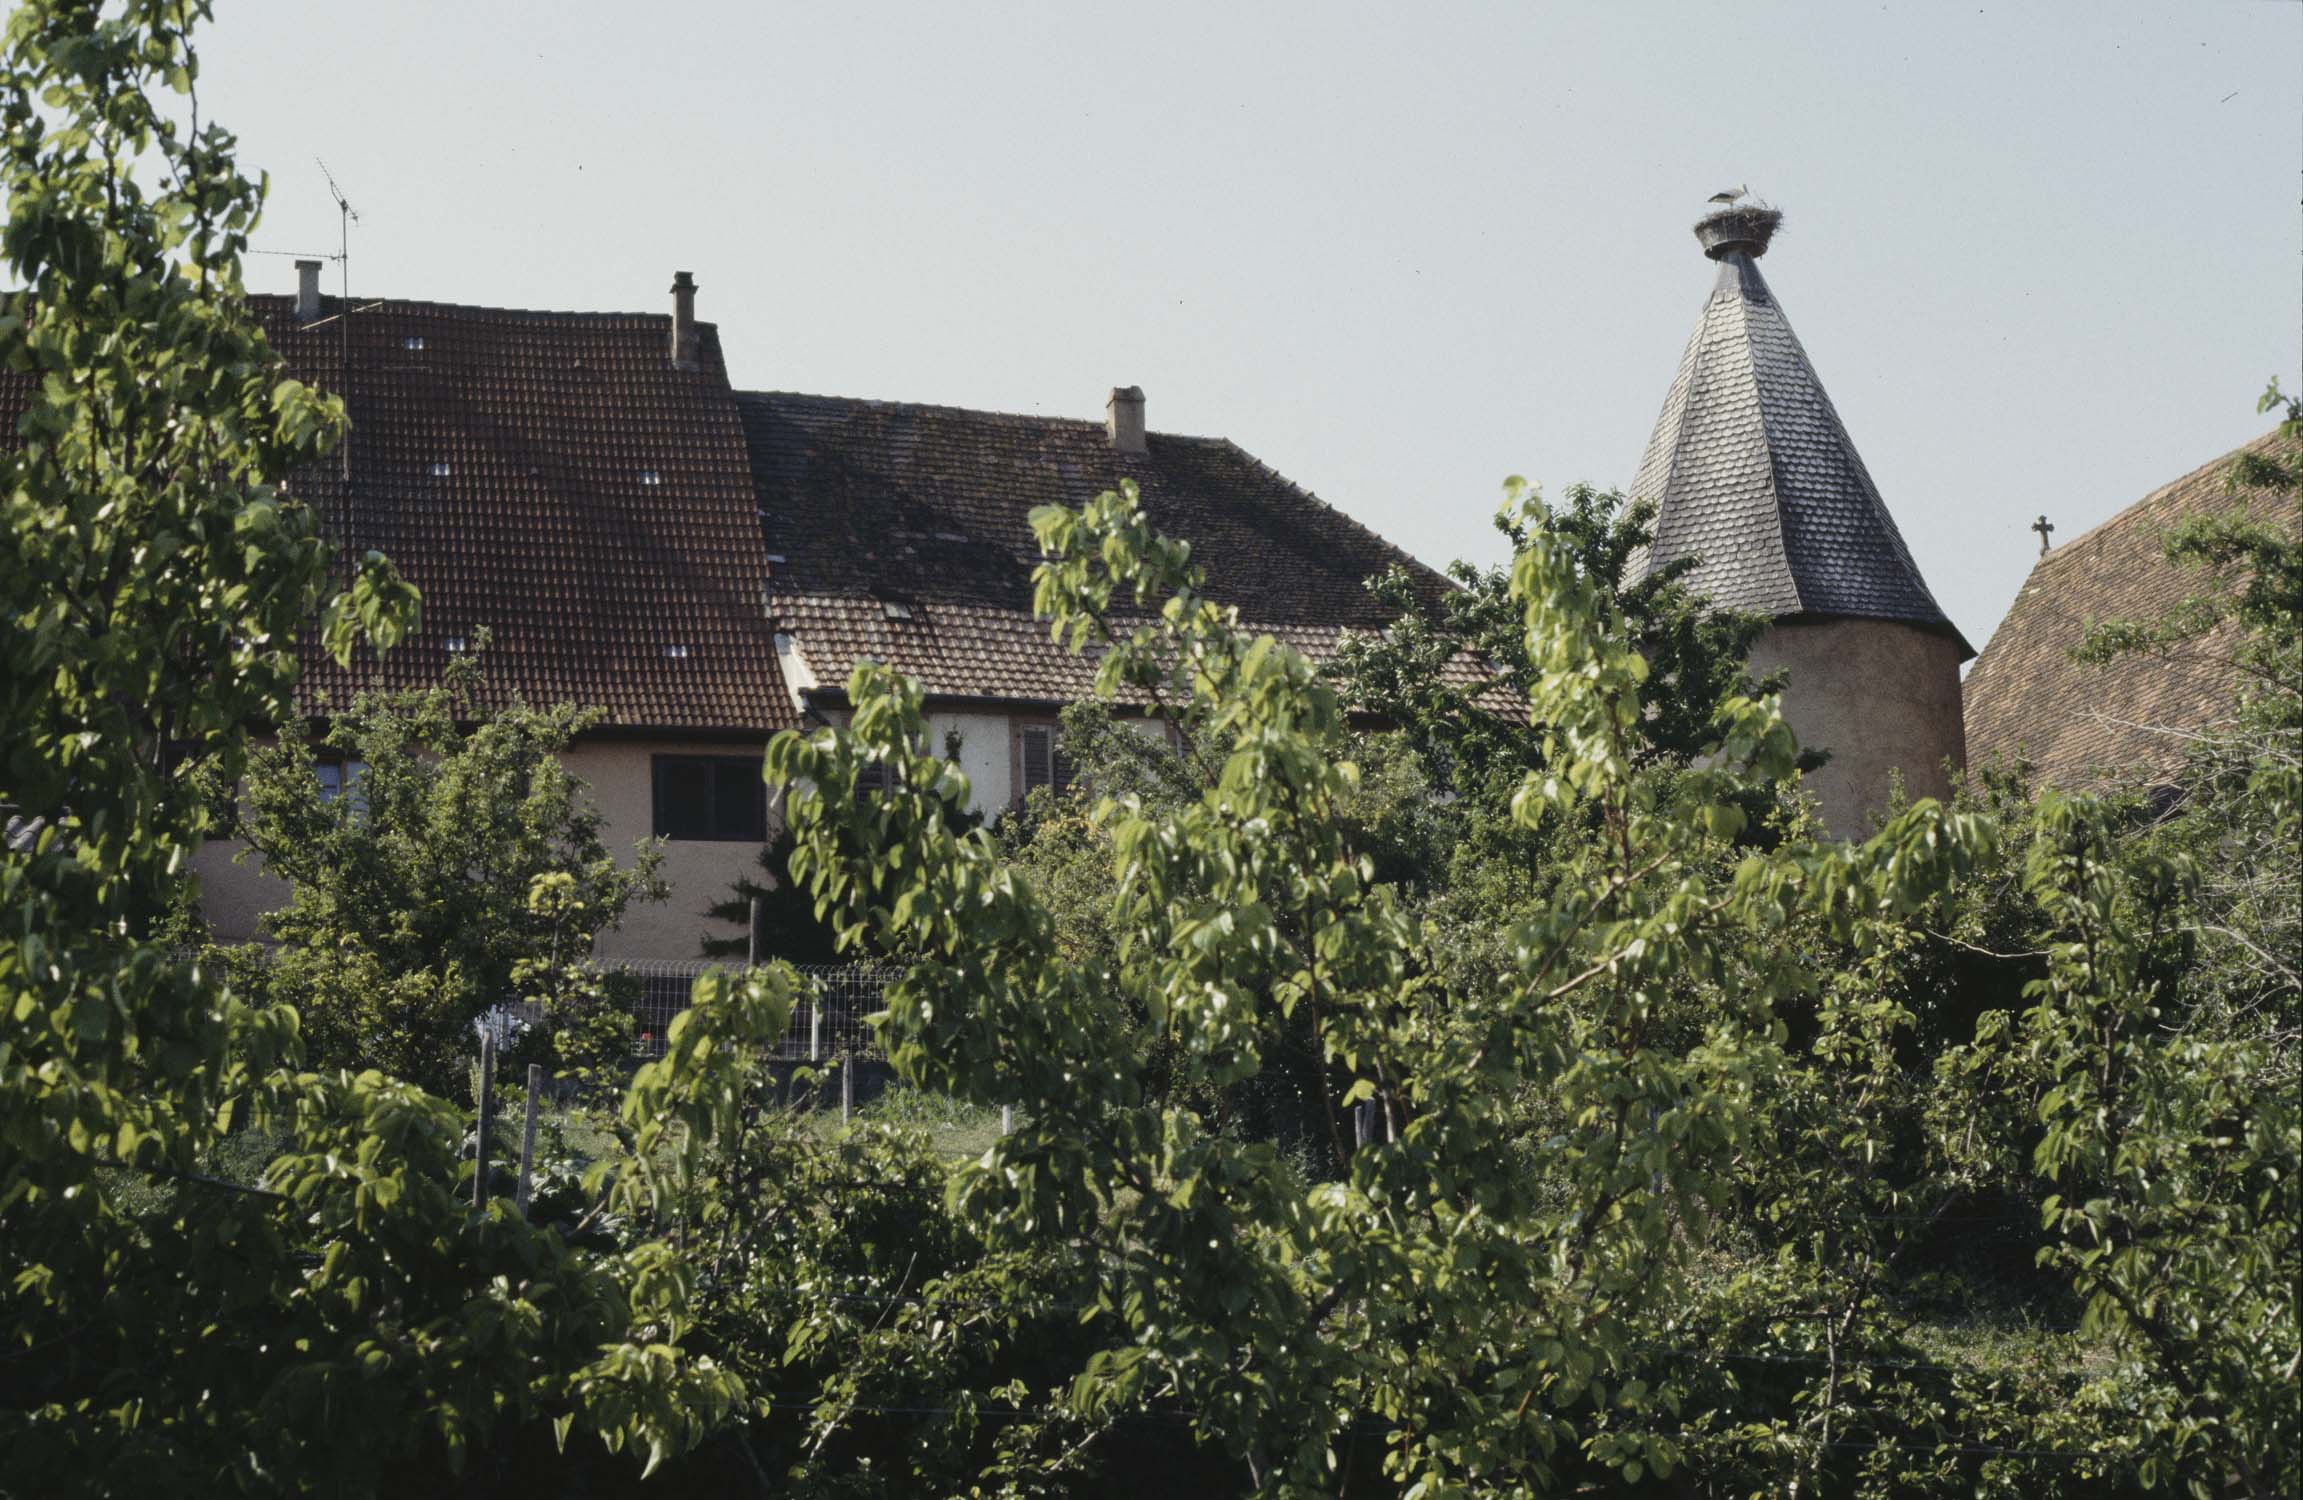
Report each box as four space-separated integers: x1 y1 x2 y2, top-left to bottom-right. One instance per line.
200 0 2303 647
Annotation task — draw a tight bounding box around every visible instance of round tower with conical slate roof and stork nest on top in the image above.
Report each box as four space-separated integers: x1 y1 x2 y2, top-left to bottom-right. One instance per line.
1631 207 1976 839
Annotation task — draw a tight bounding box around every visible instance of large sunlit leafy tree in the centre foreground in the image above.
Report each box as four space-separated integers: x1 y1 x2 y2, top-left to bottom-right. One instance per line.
769 479 1981 1493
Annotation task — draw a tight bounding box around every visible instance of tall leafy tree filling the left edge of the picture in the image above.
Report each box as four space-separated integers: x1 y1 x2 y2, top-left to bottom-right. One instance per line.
0 0 746 1493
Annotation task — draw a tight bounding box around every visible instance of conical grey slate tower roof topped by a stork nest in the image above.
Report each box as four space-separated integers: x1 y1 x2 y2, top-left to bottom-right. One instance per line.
1631 210 1971 654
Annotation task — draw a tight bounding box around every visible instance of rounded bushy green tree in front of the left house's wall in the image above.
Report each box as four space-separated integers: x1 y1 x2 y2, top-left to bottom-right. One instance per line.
237 654 663 1094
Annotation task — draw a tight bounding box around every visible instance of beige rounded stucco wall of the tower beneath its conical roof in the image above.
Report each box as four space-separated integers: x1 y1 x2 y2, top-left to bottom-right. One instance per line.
1750 620 1967 839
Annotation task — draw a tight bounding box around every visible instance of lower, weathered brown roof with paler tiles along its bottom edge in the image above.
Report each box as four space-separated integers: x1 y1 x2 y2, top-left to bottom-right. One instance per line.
737 392 1451 703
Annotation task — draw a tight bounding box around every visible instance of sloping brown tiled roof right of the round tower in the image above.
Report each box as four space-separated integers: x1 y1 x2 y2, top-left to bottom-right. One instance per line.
1964 431 2296 786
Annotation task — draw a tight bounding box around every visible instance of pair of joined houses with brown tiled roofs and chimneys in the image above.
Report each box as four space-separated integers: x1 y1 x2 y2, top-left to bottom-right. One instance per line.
179 263 1449 959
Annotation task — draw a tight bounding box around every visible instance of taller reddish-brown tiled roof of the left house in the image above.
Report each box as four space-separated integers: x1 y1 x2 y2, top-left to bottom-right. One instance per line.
0 295 797 733
